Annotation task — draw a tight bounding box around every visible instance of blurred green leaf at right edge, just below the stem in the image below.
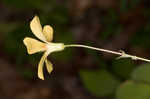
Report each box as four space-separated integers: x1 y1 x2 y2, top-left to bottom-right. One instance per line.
131 63 150 84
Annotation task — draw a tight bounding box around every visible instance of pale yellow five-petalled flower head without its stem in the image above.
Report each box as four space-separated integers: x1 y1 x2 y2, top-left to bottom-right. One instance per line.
23 16 64 80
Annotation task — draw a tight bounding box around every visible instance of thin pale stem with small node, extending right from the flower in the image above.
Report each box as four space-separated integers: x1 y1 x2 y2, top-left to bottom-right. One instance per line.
65 44 150 62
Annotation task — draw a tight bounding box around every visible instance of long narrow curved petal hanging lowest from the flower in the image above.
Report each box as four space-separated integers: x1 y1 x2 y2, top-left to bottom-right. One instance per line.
38 52 48 80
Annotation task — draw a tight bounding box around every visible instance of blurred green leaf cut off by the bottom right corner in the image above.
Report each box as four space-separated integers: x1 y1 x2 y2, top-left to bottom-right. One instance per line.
116 81 150 99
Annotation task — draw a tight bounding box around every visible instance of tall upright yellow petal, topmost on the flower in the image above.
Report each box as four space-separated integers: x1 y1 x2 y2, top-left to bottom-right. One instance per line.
30 16 46 42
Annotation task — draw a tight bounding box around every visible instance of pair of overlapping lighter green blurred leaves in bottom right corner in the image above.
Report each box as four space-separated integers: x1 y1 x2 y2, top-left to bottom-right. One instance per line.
116 64 150 99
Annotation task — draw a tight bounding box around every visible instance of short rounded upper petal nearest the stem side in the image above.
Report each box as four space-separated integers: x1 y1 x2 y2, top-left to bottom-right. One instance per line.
43 25 53 42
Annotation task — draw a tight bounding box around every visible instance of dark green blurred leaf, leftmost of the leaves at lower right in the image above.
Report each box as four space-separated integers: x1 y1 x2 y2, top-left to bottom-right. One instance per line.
80 70 119 96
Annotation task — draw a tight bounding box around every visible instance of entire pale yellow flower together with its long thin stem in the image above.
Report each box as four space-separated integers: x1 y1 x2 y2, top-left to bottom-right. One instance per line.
23 16 150 80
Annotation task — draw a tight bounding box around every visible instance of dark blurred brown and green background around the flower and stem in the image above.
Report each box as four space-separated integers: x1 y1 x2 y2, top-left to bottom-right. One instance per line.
0 0 150 99
